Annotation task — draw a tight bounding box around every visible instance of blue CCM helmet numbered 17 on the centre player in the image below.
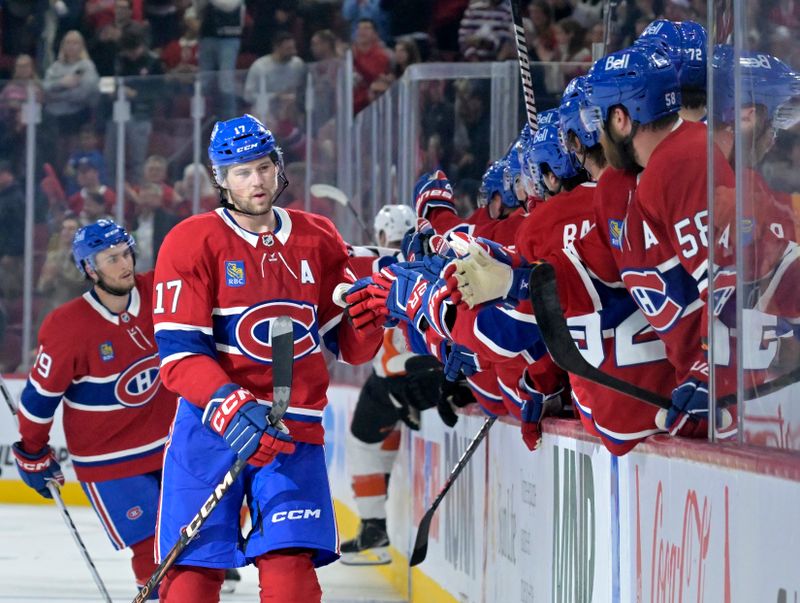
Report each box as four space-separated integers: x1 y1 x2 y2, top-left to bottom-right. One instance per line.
208 114 282 184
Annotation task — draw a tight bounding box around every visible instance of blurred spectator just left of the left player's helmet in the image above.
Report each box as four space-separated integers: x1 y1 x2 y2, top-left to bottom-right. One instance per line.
36 213 88 318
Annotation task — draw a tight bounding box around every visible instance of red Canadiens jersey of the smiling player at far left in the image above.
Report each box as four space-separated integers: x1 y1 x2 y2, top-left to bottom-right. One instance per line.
19 272 177 482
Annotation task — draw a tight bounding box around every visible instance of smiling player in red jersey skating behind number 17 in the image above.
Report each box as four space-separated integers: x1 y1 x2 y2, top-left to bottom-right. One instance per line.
13 220 176 598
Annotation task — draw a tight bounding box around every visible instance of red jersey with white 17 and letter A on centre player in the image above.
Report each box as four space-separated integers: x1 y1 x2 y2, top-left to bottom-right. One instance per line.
153 207 382 444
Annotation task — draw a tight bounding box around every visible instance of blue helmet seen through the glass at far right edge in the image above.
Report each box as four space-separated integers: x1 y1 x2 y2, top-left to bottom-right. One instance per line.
712 44 800 129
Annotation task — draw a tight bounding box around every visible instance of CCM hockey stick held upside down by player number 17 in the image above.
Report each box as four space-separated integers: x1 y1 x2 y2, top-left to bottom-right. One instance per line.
133 316 294 603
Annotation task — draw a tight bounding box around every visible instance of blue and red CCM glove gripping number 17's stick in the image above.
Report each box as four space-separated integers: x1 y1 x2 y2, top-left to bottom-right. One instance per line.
203 383 295 467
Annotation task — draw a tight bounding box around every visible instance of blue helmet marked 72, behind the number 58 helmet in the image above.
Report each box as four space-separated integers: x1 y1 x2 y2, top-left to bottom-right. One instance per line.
634 19 706 90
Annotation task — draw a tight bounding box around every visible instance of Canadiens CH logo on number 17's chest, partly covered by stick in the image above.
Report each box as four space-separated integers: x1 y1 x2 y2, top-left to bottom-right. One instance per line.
234 300 319 364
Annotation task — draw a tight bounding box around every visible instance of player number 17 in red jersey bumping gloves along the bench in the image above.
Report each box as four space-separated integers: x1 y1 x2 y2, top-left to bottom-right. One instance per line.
153 115 381 603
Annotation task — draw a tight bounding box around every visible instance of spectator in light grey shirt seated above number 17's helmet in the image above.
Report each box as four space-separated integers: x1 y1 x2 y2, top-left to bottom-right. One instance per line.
244 31 306 113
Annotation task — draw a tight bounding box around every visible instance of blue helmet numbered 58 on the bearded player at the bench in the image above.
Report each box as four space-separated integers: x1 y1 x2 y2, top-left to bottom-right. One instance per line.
581 45 681 131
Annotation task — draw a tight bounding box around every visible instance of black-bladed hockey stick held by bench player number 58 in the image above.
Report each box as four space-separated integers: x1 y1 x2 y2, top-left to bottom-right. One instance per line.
530 262 800 409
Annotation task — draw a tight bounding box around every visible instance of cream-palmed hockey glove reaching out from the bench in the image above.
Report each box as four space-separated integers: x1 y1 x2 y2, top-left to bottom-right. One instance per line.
453 243 514 308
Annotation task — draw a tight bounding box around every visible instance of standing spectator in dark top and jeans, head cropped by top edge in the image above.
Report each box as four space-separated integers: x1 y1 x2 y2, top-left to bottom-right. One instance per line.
195 0 244 119
